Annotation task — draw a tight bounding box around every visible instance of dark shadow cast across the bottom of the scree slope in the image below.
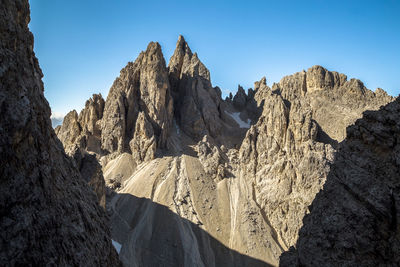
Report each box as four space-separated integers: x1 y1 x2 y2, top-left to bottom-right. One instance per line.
111 194 271 266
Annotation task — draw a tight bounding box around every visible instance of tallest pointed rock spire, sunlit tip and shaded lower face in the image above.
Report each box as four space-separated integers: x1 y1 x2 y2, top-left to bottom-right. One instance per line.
168 36 224 142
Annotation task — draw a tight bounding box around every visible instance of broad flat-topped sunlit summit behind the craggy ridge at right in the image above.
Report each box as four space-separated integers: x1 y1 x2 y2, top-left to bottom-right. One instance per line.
272 66 393 142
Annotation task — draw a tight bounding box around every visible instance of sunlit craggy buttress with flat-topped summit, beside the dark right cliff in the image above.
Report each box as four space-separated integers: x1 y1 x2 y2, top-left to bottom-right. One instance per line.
240 66 392 249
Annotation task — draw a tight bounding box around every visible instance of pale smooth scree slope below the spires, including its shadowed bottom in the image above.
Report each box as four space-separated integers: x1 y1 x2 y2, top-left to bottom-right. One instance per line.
110 155 281 266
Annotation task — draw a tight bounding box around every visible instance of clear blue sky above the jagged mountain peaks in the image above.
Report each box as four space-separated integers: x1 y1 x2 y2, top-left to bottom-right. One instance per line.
29 0 400 119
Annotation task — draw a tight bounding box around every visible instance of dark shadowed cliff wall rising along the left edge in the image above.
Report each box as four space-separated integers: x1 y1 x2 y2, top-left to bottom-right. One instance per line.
0 0 119 266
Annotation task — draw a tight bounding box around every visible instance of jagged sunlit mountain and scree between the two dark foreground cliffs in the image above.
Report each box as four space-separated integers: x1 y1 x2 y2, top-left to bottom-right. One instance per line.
55 36 400 266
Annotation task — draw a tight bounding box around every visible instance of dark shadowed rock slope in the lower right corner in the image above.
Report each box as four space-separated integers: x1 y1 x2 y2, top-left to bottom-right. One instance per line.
280 99 400 266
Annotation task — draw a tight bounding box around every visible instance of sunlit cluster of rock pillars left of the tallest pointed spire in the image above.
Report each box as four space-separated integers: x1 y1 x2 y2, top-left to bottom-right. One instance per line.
56 43 173 193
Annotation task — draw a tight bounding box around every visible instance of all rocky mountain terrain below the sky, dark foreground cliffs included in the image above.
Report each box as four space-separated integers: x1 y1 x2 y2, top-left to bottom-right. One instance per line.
0 0 400 267
